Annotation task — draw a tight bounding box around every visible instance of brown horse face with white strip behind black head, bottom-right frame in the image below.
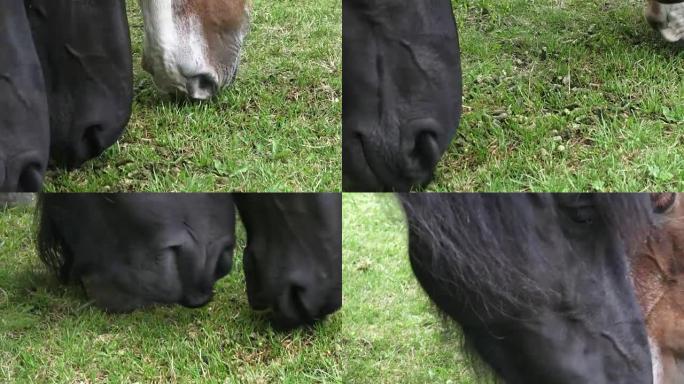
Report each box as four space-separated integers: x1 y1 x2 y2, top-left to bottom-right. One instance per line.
631 193 684 384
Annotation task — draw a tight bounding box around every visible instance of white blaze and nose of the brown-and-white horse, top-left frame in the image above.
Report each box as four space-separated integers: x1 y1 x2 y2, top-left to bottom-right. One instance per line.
139 0 220 99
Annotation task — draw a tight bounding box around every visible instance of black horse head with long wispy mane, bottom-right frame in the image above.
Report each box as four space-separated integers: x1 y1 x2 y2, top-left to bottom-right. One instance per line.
400 194 653 384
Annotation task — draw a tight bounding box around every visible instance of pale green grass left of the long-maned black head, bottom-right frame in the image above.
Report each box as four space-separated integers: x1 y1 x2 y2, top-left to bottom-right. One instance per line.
342 194 476 383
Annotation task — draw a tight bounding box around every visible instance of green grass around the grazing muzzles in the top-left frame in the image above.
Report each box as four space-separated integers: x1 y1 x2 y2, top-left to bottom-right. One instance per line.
45 0 342 192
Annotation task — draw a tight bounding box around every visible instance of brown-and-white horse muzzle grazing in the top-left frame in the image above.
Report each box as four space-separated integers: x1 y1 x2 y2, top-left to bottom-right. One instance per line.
138 0 250 100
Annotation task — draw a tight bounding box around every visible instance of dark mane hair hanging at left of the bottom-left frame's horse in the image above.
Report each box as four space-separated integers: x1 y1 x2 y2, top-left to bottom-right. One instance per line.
33 194 74 283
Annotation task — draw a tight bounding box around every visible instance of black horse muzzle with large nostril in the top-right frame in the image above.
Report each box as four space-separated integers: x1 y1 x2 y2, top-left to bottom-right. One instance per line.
342 0 461 191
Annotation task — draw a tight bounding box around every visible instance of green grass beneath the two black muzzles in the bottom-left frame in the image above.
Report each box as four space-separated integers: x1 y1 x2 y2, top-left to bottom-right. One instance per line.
0 202 348 383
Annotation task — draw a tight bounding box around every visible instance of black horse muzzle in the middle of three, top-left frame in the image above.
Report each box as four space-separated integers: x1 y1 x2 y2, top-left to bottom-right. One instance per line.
24 0 133 168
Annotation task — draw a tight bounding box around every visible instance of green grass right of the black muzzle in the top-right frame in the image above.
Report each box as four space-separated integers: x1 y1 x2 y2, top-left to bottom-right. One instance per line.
427 0 684 191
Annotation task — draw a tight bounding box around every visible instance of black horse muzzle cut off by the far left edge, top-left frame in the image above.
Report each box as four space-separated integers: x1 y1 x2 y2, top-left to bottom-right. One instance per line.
0 1 50 192
